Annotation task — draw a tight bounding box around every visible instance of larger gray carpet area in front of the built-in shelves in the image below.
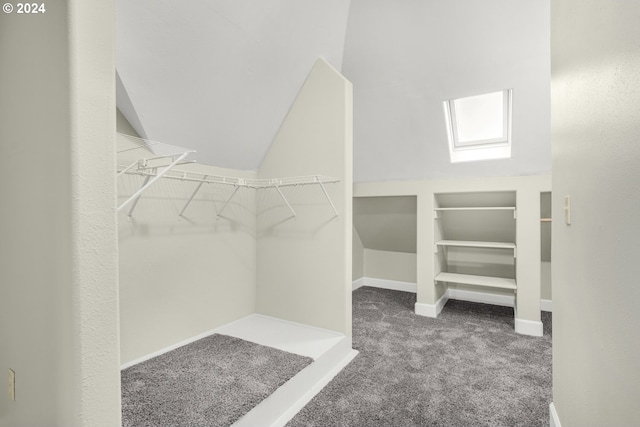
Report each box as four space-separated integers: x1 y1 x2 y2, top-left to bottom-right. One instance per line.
287 287 551 427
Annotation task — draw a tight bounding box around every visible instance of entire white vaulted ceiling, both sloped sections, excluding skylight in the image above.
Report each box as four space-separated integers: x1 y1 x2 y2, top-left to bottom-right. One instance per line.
116 0 551 181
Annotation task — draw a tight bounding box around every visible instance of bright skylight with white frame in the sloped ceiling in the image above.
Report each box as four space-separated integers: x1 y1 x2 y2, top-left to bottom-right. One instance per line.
444 89 511 163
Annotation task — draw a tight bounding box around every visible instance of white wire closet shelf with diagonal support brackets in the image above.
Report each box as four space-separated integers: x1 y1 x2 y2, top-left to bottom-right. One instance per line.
116 133 340 221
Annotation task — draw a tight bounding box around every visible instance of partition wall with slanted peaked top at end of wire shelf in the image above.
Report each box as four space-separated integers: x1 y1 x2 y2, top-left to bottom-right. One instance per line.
256 59 353 335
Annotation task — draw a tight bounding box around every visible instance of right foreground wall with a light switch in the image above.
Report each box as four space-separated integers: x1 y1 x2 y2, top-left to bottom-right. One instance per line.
551 0 640 427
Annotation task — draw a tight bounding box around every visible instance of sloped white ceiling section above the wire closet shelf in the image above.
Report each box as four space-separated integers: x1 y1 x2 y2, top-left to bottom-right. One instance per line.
116 0 349 170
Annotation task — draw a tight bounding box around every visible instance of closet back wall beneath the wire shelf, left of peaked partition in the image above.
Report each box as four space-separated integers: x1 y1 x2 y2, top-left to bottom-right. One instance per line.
118 162 256 364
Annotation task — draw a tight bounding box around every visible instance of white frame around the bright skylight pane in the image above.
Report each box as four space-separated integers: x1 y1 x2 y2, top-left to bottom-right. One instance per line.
443 89 513 163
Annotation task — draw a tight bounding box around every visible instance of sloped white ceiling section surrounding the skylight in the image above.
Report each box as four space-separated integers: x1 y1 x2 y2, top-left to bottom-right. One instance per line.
343 0 551 182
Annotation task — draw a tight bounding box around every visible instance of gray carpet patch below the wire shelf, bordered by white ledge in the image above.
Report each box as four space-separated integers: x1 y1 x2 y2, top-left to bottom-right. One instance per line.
122 334 312 427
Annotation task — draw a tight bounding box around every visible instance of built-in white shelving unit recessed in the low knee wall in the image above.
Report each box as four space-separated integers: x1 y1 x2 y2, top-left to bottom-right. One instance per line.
434 191 518 312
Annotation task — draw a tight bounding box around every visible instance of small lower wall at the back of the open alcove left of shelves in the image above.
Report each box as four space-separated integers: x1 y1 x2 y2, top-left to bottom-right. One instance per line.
364 249 417 283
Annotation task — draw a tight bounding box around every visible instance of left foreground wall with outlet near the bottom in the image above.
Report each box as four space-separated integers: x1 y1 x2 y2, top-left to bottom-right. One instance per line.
0 0 120 427
